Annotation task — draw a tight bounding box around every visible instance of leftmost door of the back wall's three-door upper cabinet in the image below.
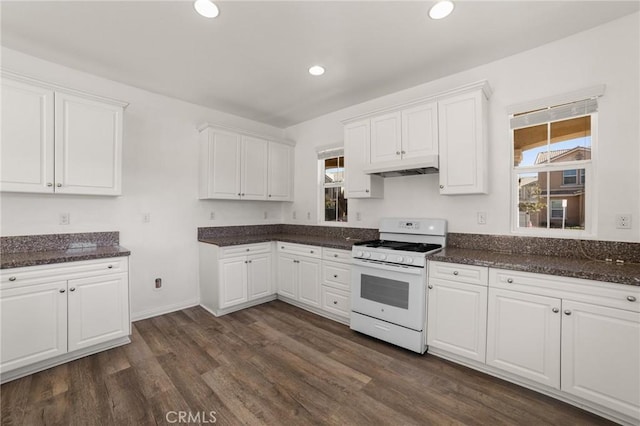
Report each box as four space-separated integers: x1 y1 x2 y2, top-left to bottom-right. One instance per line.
200 129 241 199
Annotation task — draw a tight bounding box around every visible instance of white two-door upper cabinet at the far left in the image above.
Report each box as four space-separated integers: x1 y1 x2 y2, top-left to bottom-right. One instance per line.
0 73 126 195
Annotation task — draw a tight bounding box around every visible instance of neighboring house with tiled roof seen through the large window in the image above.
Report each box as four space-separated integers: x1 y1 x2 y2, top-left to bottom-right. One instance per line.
519 146 591 229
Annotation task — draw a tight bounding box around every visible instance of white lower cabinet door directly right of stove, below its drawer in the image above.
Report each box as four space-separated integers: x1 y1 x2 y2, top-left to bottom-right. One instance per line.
427 279 487 362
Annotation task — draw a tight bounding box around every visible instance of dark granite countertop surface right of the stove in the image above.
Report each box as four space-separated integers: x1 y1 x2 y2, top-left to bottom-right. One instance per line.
428 247 640 286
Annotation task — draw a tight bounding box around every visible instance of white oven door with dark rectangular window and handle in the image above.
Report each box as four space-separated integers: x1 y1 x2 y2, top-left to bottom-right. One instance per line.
351 259 427 331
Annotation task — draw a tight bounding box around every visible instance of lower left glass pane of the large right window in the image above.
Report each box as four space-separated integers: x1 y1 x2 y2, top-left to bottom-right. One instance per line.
518 172 548 228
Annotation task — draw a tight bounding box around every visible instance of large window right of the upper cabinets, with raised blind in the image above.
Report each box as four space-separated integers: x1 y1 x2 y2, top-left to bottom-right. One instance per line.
511 98 598 234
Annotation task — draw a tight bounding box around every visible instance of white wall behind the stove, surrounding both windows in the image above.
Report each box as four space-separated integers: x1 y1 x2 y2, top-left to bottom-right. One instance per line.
284 13 640 241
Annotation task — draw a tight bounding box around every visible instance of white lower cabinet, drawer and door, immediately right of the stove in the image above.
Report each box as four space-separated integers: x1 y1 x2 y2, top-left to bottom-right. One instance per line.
427 262 488 362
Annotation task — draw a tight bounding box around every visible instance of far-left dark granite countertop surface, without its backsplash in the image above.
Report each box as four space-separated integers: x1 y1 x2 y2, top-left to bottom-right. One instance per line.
0 246 131 269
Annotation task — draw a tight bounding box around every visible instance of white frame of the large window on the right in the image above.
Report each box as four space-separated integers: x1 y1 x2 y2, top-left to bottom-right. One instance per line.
508 108 599 238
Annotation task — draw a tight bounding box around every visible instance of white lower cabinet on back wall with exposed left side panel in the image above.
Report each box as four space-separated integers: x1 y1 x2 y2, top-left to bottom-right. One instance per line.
200 243 275 315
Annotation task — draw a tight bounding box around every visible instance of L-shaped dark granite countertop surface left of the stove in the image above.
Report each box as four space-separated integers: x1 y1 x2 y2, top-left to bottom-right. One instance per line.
198 233 361 250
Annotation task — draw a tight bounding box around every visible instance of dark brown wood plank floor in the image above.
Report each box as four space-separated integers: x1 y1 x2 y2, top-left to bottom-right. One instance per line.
0 301 608 426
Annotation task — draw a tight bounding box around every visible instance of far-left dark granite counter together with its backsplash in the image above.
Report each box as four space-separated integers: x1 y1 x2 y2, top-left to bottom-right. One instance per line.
0 232 131 269
